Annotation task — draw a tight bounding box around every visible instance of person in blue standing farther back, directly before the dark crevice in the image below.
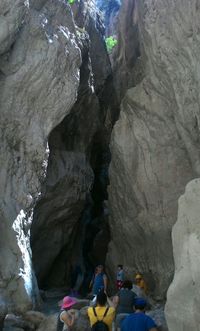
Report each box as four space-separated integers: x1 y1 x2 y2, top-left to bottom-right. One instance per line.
91 264 107 296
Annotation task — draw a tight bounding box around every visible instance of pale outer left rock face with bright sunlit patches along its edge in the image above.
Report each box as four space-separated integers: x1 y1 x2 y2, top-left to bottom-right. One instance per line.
0 0 81 311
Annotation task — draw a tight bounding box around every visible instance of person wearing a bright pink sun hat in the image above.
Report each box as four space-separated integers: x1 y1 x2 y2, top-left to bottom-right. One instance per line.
57 296 77 331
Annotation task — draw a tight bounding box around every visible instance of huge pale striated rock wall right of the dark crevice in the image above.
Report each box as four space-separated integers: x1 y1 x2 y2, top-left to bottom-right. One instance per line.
107 0 200 296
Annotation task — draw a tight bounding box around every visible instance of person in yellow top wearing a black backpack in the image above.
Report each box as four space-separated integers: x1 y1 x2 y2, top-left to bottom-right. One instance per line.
88 290 115 331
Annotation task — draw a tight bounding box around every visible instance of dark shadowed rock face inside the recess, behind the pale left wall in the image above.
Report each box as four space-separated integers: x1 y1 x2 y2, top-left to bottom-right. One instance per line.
31 1 117 288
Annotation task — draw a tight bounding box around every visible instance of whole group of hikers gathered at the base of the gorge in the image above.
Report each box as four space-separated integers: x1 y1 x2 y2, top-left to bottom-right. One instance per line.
58 265 157 331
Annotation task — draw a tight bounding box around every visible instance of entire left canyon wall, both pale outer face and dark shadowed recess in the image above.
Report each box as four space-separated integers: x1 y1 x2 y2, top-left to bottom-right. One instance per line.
0 0 118 316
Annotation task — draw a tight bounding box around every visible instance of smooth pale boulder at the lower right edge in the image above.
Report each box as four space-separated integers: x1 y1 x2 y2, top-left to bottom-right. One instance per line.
165 179 200 331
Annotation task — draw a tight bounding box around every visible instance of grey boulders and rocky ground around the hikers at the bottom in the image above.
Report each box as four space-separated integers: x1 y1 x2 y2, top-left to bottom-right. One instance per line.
3 289 168 331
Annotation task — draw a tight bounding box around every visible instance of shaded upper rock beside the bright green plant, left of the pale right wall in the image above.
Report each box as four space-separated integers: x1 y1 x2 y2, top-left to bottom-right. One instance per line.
106 0 143 101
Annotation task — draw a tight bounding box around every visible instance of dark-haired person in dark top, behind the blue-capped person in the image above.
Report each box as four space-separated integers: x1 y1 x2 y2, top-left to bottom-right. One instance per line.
114 280 136 330
